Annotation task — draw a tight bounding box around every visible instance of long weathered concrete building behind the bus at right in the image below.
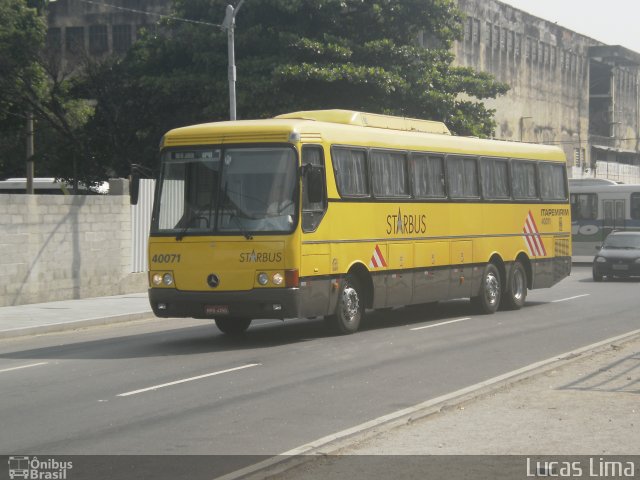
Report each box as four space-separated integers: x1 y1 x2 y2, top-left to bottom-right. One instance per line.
454 0 640 183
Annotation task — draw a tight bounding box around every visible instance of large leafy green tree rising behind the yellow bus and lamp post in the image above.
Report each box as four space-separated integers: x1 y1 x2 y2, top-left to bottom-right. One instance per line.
85 0 508 174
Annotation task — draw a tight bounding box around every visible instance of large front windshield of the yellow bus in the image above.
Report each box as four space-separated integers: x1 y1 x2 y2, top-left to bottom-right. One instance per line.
151 147 298 238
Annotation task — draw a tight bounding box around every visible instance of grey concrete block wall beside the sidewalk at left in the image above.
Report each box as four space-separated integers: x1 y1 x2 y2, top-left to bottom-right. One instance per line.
0 195 146 306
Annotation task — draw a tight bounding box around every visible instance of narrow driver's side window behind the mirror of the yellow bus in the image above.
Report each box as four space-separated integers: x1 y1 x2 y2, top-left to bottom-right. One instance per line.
302 145 327 232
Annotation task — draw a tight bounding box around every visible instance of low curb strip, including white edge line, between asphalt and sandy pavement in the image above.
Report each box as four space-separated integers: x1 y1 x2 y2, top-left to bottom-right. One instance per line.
216 329 640 480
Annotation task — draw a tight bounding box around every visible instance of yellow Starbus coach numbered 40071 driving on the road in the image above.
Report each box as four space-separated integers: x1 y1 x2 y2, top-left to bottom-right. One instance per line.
149 110 571 334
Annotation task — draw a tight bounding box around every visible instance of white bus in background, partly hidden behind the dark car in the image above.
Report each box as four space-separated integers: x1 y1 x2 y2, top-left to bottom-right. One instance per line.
569 180 640 256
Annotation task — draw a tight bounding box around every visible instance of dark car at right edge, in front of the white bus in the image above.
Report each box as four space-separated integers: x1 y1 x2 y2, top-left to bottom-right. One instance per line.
593 230 640 282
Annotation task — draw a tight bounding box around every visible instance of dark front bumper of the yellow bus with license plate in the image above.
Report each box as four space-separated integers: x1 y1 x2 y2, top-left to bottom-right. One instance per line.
149 288 300 319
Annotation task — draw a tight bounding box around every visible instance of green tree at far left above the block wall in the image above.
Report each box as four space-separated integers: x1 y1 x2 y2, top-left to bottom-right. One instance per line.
0 0 97 183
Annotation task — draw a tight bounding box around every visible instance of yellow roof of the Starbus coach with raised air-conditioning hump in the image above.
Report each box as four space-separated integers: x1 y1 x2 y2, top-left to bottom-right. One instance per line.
161 110 565 162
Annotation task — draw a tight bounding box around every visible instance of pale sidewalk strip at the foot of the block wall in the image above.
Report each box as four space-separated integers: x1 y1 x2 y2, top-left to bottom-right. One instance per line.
0 292 153 339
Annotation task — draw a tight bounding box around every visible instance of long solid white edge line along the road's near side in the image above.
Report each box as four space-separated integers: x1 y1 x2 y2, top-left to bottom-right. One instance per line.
216 329 640 480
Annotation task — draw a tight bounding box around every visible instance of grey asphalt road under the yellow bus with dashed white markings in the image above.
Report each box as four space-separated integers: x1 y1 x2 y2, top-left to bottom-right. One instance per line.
0 267 640 476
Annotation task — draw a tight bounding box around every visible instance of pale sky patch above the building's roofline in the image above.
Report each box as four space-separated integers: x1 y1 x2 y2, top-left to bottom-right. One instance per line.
501 0 640 53
